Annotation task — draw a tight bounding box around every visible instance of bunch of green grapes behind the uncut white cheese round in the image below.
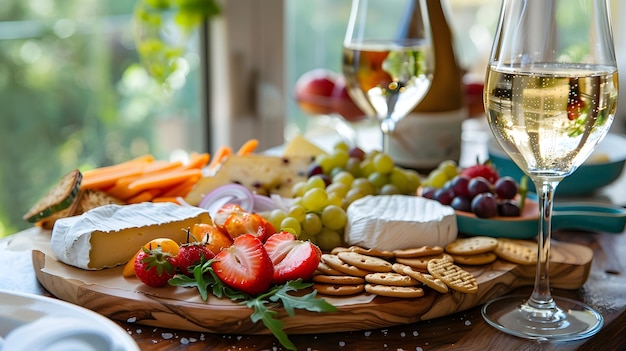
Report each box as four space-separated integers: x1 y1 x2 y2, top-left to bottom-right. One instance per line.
267 143 421 251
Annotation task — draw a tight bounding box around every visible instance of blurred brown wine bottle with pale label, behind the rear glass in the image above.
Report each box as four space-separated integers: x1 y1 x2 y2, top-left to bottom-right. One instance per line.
389 0 467 171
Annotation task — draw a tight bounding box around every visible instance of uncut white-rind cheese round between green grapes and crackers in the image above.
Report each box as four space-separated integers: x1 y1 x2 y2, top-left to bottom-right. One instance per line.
345 195 458 250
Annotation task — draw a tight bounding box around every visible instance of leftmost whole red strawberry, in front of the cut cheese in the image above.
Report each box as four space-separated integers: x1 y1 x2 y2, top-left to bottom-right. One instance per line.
135 246 176 288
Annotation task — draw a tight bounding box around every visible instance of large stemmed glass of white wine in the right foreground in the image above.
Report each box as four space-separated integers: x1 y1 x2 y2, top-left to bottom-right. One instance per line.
482 0 618 341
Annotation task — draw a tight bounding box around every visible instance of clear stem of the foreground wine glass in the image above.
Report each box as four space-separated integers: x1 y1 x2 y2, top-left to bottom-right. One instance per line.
527 179 559 310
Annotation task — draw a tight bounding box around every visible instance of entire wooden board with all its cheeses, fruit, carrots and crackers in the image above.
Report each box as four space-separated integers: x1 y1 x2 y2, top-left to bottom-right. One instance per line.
16 138 593 348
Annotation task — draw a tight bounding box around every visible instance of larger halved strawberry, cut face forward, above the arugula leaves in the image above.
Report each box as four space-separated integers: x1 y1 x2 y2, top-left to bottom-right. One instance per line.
213 234 274 295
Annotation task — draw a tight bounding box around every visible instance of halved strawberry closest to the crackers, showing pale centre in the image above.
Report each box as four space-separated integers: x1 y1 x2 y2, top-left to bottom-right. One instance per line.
264 232 322 284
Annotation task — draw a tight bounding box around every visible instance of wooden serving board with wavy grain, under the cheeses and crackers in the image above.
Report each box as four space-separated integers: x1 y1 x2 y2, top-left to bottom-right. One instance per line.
33 241 593 334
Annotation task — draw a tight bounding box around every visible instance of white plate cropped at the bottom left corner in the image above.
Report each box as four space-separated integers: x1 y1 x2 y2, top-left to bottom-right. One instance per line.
0 290 139 351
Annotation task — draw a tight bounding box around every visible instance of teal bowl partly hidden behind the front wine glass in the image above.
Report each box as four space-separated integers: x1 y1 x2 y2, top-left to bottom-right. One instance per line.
488 134 626 195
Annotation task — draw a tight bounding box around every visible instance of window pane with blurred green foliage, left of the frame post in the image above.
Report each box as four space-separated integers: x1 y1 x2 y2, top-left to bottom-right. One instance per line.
0 0 206 237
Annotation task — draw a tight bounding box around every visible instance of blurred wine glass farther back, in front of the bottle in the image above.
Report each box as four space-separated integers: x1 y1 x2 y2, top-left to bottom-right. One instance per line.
342 0 433 152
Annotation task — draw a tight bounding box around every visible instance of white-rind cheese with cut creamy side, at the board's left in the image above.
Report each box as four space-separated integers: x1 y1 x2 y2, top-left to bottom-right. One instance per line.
50 202 212 270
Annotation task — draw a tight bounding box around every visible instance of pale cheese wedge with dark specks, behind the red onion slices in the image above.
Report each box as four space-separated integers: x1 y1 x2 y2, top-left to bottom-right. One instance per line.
185 154 313 206
